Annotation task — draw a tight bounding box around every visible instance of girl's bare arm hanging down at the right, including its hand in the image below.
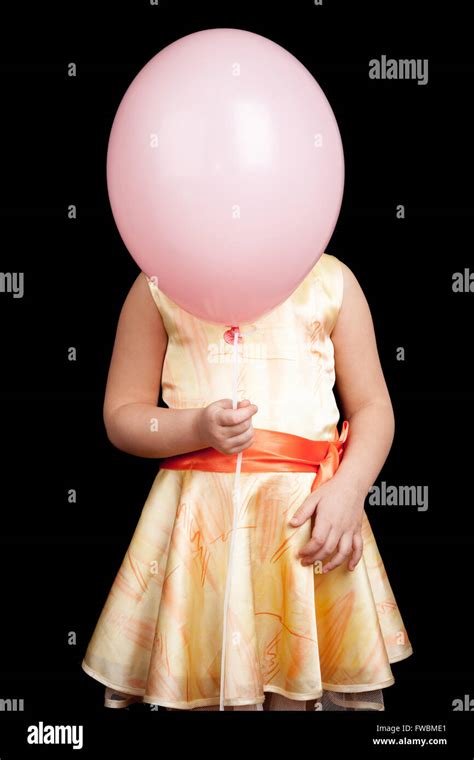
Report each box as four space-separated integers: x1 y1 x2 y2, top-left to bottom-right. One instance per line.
291 262 395 572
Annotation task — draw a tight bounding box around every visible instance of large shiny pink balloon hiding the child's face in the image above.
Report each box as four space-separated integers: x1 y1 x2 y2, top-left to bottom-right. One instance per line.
107 29 344 326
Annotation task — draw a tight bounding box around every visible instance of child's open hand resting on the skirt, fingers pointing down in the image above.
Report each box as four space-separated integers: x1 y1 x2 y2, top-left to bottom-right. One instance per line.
290 473 365 573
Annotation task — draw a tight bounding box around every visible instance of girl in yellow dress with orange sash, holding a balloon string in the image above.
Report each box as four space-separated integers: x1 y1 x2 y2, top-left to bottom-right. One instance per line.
82 253 412 710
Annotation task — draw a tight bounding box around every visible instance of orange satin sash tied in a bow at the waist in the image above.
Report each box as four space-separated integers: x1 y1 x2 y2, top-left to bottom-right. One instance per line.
160 420 349 491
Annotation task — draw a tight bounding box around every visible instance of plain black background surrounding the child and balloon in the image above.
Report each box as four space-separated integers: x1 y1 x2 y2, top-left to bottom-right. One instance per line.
0 0 474 760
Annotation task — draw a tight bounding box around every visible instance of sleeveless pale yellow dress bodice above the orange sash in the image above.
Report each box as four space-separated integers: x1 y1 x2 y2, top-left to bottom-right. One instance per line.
147 253 343 440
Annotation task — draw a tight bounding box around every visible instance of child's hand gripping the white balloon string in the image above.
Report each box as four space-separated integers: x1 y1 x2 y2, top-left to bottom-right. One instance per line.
198 398 257 454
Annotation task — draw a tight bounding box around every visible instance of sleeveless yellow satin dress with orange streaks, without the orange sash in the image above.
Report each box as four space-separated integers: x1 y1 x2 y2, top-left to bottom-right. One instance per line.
82 253 412 710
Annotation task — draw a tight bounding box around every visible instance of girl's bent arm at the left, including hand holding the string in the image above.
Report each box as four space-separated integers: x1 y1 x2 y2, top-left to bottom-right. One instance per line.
104 272 257 458
